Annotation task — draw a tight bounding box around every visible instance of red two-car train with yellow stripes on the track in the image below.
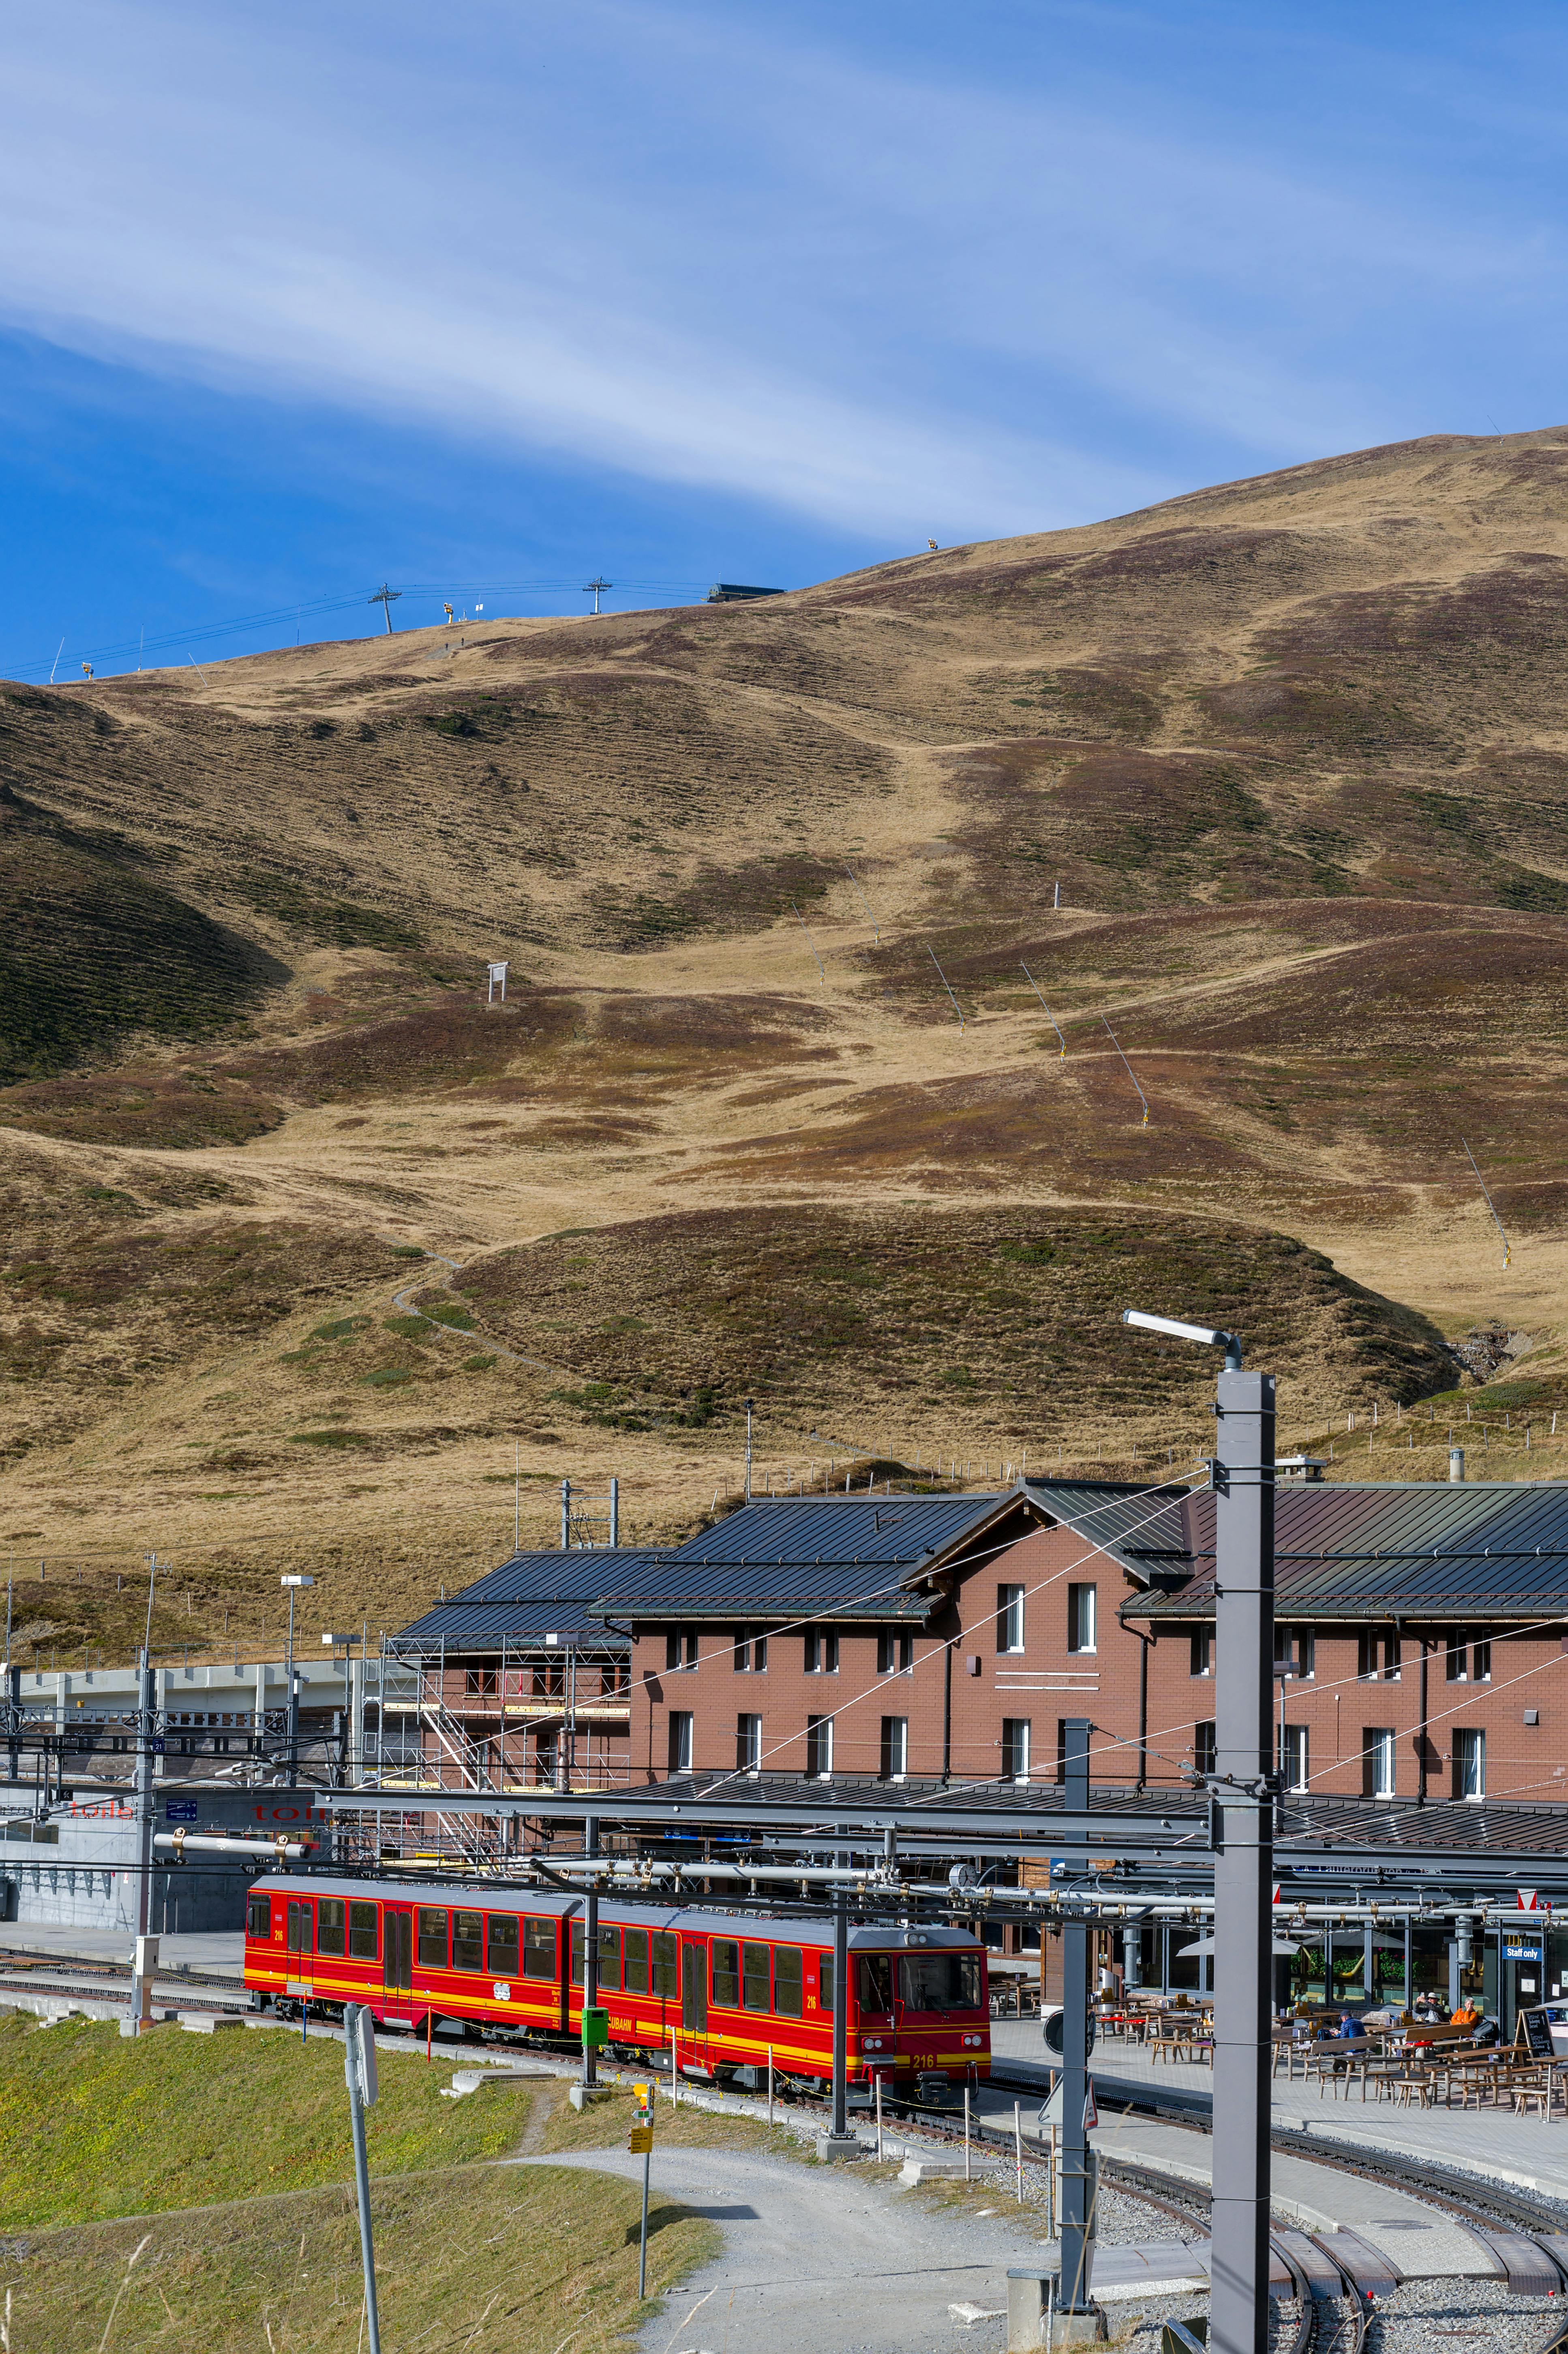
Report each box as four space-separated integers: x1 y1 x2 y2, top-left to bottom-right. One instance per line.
245 1874 991 2090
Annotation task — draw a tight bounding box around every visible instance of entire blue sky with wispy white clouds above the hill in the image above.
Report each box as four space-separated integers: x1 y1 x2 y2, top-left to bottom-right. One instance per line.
0 0 1568 678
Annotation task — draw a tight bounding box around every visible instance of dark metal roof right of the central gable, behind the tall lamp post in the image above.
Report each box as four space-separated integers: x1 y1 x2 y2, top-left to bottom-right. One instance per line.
1125 1481 1568 1620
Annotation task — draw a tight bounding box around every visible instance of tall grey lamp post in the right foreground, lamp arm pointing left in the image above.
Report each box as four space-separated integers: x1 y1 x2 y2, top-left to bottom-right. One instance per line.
1123 1309 1279 2354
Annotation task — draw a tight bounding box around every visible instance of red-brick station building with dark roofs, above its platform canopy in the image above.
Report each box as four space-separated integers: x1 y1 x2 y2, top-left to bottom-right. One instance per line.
579 1481 1568 1803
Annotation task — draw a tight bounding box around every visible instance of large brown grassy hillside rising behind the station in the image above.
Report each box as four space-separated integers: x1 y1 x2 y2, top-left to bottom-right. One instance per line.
0 431 1568 1638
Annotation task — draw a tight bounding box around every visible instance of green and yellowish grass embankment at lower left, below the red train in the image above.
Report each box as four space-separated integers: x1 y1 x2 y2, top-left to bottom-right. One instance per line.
0 2020 739 2354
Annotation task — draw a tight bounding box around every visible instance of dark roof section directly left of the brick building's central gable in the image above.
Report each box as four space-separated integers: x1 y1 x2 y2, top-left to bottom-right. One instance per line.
595 1488 1043 1624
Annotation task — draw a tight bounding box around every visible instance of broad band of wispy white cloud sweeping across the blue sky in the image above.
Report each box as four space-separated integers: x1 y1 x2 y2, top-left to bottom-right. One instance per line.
0 0 1561 537
